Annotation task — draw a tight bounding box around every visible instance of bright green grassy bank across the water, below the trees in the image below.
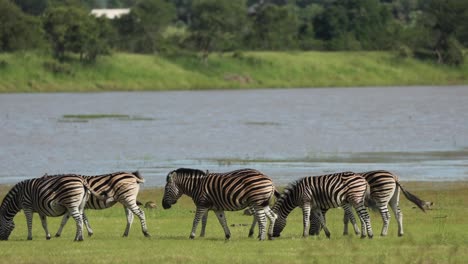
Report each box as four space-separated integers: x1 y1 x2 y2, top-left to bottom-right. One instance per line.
0 52 468 93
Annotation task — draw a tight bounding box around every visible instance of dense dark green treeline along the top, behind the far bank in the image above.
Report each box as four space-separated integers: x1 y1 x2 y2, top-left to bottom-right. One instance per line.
0 0 468 65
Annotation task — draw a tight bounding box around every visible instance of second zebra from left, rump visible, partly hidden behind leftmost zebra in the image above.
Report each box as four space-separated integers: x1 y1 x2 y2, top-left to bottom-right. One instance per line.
52 171 150 237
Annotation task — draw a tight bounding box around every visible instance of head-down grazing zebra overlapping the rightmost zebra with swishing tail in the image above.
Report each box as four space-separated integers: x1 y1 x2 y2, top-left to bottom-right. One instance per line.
273 172 373 238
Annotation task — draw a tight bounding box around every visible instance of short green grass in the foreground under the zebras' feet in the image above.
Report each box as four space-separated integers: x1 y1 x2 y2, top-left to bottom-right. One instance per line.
0 182 468 264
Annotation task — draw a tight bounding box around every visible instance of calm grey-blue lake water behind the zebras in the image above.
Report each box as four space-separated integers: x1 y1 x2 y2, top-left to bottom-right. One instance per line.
0 86 468 187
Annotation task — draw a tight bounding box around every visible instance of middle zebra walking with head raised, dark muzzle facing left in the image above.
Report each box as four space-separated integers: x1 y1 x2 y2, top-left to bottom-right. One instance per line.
162 168 276 240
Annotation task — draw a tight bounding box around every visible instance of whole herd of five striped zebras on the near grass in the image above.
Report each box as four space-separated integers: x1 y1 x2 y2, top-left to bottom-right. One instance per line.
0 168 427 241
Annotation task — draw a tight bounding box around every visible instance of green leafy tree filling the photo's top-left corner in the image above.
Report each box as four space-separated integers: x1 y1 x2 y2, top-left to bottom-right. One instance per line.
0 0 43 51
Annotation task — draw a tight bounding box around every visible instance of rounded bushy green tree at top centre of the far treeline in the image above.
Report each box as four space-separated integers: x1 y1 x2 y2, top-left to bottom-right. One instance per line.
189 0 247 58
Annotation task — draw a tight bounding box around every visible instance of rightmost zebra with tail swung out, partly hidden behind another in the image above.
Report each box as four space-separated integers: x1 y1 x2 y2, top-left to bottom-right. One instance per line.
310 170 427 236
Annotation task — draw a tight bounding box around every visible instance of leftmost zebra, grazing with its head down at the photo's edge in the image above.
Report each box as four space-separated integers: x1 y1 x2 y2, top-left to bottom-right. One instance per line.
0 174 107 241
